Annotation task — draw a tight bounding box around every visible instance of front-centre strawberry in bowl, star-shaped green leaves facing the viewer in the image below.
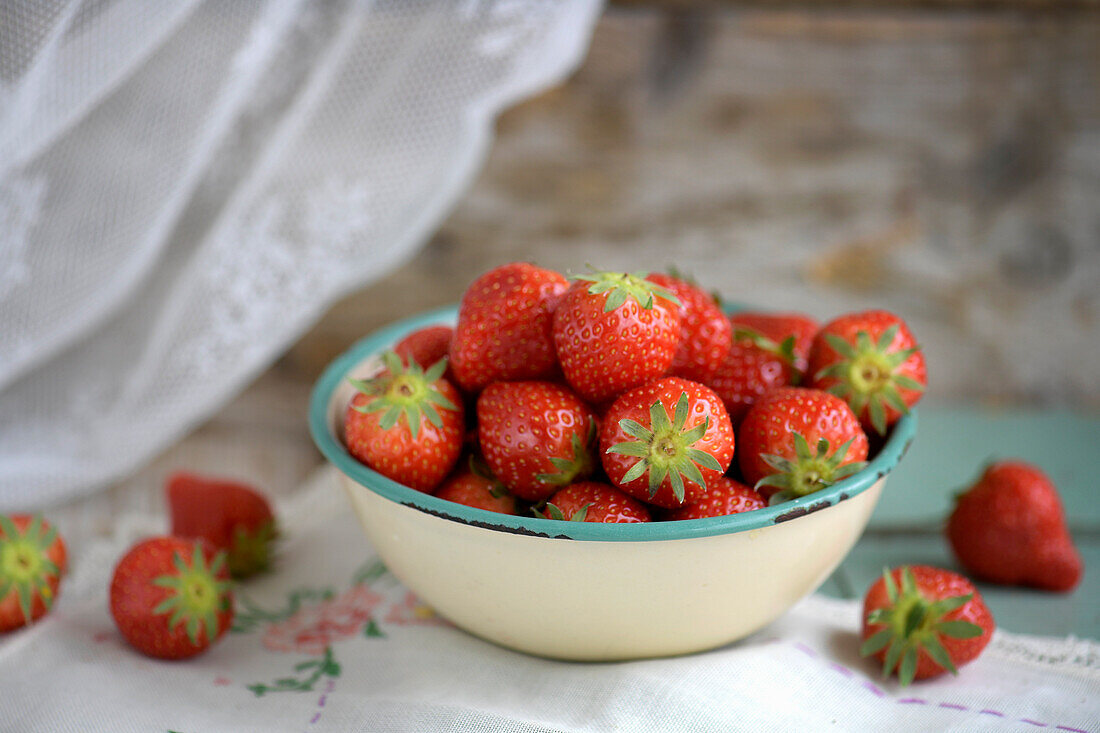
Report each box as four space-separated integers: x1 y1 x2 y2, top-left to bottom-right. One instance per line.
600 376 734 508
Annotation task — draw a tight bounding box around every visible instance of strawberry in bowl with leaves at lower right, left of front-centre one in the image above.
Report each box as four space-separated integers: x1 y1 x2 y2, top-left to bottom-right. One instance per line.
477 382 596 502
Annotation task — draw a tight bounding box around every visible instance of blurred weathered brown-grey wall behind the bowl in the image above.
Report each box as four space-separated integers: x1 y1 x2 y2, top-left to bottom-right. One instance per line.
283 7 1100 408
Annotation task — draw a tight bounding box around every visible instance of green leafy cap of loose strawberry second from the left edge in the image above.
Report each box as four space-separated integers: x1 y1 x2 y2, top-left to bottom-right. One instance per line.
152 543 231 646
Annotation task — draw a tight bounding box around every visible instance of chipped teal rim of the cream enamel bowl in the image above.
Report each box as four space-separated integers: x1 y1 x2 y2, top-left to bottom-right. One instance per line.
309 304 916 541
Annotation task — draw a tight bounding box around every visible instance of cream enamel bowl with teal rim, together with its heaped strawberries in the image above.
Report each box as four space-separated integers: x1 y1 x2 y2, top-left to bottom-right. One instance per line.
310 263 925 660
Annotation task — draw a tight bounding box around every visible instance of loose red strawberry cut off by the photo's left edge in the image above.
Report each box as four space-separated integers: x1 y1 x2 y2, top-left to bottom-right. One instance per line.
0 514 68 633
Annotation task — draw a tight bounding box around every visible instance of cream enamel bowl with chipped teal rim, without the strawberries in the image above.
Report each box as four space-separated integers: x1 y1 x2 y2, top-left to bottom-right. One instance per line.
309 308 916 660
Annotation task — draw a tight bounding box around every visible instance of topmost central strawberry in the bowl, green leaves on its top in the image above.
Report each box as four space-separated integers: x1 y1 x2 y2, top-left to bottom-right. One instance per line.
553 272 680 405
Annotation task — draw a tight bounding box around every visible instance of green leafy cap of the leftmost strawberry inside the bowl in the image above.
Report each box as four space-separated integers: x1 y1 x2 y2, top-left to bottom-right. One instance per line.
348 351 459 440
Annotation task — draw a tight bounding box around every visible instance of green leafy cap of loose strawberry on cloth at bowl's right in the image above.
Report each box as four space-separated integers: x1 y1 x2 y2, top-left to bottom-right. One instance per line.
859 567 985 687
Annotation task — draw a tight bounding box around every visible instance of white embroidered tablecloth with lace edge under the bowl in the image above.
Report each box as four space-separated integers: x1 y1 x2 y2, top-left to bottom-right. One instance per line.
0 469 1100 733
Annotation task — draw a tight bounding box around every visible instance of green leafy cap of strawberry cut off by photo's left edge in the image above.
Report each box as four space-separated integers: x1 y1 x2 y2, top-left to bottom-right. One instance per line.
0 514 61 623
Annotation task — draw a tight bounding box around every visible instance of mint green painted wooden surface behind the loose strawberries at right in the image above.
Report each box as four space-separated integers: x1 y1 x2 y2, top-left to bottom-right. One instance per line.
822 405 1100 638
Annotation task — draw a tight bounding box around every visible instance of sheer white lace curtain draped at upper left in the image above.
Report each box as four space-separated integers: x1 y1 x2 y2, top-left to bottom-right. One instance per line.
0 0 598 510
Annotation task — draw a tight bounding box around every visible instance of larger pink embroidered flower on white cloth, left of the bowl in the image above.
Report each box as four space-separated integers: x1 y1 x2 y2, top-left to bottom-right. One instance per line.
263 586 384 655
